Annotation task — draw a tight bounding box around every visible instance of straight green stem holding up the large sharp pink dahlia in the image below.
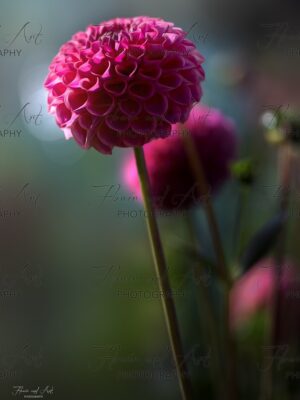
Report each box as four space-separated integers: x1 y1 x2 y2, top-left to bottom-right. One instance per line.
134 147 192 400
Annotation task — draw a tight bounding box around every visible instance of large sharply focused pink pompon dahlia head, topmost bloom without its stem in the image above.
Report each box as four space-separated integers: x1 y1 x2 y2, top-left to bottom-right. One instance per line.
45 17 204 154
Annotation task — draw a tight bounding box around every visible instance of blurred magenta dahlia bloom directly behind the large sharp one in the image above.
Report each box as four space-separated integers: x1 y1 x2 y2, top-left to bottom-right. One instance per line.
122 105 236 210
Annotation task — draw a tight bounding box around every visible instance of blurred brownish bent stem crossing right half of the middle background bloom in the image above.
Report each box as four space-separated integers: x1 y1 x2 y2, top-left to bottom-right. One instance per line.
182 130 237 400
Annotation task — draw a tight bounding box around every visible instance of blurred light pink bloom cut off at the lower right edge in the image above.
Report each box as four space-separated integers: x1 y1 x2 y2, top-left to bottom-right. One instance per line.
230 258 300 338
